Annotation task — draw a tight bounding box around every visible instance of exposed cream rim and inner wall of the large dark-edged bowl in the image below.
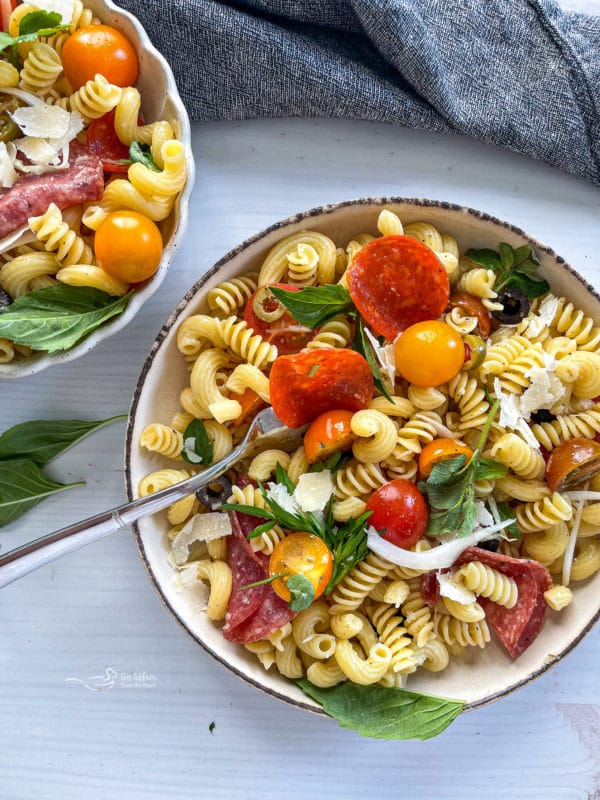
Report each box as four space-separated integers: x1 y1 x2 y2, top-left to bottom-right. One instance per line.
126 198 600 711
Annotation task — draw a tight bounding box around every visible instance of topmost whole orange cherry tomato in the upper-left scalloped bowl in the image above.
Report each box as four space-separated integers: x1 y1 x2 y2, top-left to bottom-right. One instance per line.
61 25 138 89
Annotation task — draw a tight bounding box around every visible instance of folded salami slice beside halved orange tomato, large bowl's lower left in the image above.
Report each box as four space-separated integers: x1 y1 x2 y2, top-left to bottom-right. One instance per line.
223 512 295 643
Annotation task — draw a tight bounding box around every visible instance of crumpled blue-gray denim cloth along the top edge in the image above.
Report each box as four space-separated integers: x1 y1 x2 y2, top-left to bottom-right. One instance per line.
120 0 600 185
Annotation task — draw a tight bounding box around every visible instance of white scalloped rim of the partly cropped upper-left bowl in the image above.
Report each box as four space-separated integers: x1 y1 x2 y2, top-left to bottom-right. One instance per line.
0 0 194 378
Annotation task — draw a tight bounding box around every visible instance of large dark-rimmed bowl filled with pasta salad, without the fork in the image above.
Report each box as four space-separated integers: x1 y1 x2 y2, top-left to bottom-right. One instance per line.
126 198 600 739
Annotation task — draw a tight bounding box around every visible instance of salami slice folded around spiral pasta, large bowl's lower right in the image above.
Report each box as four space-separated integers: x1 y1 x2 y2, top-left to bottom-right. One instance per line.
455 547 552 658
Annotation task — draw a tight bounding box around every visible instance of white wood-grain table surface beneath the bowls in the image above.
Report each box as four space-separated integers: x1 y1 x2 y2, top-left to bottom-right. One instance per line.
0 70 600 800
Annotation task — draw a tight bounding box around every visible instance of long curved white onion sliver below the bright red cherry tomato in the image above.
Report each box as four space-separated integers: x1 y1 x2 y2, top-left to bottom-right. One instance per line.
367 519 514 572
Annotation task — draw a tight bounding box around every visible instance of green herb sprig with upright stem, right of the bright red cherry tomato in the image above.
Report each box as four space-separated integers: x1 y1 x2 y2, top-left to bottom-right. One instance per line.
419 399 508 538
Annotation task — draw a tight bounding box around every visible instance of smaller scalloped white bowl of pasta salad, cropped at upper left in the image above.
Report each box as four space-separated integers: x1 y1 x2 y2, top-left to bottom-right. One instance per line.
0 0 194 378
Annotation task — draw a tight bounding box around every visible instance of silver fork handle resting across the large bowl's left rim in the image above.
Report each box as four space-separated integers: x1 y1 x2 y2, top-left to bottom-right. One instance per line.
0 443 245 589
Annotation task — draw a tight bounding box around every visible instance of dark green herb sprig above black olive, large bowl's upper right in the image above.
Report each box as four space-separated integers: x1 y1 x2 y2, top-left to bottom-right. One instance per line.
465 242 550 300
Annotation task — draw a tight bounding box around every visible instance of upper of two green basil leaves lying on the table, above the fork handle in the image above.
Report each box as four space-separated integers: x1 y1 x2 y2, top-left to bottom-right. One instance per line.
0 414 127 464
